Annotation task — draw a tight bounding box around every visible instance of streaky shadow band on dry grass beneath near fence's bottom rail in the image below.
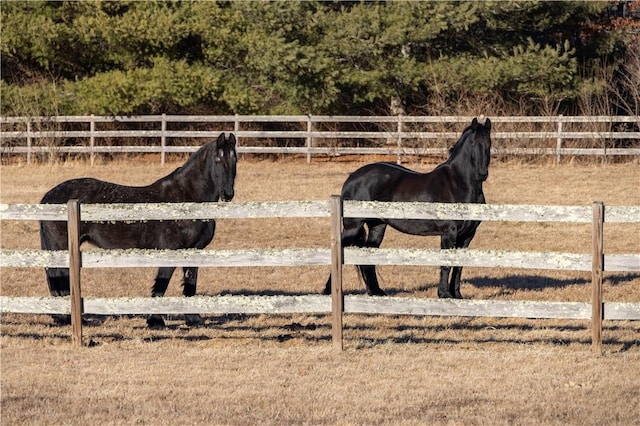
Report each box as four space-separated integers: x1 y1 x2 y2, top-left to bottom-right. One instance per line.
2 314 640 353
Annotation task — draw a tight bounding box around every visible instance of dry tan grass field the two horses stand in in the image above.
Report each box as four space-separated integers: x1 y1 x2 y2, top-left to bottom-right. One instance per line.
0 154 640 425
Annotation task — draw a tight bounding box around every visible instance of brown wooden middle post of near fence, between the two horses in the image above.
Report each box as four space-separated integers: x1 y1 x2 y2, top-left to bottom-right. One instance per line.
331 195 344 351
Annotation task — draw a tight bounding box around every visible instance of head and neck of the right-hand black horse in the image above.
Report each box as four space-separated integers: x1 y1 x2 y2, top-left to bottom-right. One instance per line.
449 118 491 182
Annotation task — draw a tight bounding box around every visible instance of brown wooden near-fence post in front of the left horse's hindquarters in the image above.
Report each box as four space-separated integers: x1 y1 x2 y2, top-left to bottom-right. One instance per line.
67 200 83 348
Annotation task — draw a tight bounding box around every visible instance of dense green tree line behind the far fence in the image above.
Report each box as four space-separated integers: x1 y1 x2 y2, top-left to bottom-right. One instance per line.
0 0 640 115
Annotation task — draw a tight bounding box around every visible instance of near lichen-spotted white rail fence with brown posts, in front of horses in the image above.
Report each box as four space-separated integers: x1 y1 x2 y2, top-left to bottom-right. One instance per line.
0 196 640 351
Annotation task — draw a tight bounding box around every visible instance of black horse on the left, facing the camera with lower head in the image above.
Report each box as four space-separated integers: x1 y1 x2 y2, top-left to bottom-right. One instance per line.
40 133 237 328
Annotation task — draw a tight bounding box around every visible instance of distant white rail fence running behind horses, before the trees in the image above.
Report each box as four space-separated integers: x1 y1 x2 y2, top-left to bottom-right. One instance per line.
0 114 640 164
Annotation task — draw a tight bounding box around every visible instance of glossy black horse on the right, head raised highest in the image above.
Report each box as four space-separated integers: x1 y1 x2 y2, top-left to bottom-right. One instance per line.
324 118 491 299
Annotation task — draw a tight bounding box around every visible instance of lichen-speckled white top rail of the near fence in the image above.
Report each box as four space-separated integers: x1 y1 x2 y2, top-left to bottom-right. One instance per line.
5 200 640 223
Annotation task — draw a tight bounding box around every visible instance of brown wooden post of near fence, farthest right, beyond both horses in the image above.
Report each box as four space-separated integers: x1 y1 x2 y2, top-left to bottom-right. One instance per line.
591 201 604 354
